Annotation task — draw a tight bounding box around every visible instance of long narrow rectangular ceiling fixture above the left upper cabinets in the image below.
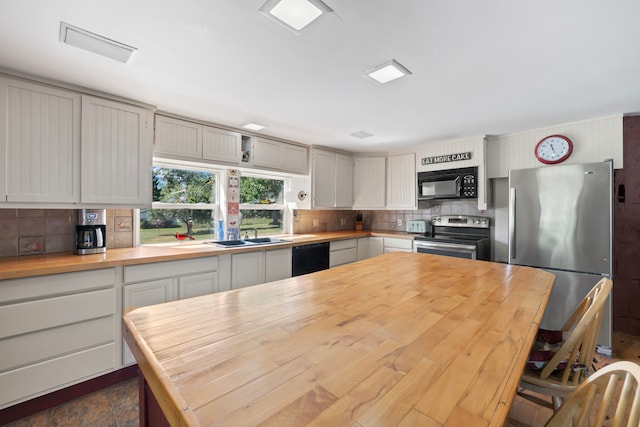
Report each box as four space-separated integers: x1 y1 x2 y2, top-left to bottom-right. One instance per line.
60 22 138 63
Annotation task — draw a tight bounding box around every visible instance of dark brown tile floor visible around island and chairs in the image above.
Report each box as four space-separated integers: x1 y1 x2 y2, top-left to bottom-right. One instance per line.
6 332 640 427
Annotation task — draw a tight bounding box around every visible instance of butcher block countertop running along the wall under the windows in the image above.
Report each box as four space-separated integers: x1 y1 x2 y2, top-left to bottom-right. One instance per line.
0 231 413 280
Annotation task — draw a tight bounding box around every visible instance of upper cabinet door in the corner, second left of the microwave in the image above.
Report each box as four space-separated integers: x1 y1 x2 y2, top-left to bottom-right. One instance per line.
353 157 387 209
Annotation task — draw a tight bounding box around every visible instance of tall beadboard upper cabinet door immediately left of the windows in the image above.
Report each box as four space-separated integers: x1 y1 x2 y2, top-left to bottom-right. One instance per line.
81 95 153 207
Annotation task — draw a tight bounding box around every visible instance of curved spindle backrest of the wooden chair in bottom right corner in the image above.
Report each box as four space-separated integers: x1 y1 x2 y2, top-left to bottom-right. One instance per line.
546 362 640 427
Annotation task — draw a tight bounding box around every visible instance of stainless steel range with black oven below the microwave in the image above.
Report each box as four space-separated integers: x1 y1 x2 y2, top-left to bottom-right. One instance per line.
413 215 491 261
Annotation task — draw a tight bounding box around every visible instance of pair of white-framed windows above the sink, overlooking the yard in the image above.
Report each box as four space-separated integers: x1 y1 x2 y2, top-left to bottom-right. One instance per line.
138 162 287 245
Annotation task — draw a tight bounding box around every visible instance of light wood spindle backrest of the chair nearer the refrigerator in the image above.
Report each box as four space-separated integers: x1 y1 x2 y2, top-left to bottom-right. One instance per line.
540 278 613 385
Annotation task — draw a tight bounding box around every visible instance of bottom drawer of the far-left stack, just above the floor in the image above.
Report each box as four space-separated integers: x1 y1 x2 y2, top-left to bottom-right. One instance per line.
0 343 115 409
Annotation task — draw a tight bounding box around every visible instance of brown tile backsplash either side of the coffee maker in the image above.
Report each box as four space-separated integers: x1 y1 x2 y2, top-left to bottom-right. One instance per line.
0 209 133 257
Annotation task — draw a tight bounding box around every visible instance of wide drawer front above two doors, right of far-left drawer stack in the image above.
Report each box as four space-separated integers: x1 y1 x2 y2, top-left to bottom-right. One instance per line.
124 256 218 283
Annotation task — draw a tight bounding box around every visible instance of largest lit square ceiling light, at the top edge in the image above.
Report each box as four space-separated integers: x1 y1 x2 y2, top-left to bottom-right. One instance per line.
260 0 333 34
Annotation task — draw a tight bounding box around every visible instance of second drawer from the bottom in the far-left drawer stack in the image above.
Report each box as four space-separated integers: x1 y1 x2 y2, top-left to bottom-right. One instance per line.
0 316 116 372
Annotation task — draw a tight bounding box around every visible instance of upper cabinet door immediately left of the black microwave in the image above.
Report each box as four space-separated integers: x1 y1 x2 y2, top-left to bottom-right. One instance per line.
387 153 417 209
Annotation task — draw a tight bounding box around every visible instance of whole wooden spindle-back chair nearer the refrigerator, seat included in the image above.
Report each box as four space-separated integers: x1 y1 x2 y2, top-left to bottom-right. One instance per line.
518 278 613 411
